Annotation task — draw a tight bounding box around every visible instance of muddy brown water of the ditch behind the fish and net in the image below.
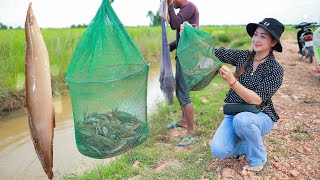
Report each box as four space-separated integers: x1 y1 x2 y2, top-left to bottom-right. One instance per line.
0 67 169 180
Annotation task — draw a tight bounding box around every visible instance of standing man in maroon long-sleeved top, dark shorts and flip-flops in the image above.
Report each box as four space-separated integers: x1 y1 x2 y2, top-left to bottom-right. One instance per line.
167 0 199 146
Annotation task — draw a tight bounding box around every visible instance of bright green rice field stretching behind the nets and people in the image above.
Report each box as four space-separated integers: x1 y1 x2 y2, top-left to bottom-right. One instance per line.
0 26 255 97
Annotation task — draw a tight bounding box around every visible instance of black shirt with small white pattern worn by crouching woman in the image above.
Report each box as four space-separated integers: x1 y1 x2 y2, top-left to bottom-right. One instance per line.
215 48 284 122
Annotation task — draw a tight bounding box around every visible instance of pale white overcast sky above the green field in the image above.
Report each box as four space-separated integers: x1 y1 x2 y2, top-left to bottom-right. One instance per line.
0 0 320 28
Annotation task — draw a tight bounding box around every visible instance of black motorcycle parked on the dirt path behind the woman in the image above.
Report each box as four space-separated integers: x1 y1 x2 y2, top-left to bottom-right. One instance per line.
293 22 319 63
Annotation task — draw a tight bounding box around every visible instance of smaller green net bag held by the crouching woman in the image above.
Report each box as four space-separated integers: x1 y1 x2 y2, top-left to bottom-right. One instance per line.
177 23 222 91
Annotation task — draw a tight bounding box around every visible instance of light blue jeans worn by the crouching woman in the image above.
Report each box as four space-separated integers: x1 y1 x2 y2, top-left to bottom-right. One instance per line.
211 112 274 166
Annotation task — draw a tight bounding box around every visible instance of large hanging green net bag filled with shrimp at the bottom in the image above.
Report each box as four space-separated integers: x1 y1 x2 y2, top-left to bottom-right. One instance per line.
66 0 149 159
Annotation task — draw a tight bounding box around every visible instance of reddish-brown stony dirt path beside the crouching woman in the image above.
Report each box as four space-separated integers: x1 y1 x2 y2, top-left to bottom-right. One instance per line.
208 40 320 179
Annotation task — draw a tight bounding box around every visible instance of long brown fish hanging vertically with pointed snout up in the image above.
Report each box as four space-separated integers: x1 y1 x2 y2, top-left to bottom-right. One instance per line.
25 3 55 179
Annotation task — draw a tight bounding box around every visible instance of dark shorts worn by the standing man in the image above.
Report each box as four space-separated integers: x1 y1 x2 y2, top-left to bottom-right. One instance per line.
176 57 191 106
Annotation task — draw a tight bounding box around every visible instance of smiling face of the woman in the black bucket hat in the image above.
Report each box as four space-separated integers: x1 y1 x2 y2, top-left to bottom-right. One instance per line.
252 26 277 53
